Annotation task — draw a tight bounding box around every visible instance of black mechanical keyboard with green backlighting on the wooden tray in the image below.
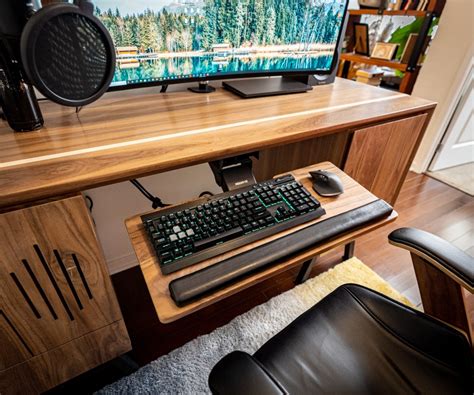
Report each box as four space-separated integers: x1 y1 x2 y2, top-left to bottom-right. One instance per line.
141 175 325 274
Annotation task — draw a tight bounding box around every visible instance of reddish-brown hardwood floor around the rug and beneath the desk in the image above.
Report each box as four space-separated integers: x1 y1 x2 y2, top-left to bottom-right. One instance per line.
46 173 474 392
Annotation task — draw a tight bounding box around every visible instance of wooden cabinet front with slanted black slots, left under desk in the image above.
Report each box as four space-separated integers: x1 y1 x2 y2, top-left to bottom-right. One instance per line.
0 196 130 393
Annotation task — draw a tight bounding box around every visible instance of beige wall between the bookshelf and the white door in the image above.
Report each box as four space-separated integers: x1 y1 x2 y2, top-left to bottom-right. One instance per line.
412 0 474 172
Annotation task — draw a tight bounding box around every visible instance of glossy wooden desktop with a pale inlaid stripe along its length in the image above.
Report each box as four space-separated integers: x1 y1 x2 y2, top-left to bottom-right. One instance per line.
0 79 435 207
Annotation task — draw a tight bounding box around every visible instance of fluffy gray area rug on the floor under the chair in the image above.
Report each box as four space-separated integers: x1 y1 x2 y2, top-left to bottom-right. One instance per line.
98 258 410 394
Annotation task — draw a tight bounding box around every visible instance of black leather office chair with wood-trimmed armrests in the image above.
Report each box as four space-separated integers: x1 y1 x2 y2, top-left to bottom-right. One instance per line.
209 228 474 395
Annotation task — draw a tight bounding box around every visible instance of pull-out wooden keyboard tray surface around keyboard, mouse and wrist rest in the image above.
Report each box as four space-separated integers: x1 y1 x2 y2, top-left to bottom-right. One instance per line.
126 162 397 323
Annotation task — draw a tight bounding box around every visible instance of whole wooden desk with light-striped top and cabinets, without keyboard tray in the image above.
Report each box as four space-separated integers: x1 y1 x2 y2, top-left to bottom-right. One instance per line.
0 79 435 393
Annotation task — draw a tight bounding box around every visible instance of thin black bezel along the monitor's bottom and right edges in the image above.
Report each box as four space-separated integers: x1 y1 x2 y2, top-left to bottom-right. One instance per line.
108 0 349 92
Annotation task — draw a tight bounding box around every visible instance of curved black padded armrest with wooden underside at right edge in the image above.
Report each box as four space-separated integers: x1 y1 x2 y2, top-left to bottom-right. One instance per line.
388 228 474 293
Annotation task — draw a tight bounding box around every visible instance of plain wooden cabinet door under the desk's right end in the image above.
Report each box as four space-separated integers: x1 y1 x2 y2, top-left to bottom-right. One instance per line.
344 114 426 205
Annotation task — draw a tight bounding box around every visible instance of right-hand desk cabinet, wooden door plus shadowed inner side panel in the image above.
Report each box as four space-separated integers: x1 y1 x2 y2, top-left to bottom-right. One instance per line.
254 114 427 205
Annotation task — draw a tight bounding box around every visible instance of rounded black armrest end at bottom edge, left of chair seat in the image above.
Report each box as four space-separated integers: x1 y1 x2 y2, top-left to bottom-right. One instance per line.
209 351 287 395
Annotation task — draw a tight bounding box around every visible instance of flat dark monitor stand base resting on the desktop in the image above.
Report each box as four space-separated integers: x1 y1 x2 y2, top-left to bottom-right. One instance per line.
222 77 313 98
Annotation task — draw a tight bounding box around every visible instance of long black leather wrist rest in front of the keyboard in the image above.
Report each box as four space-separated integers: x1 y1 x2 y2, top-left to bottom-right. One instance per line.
169 199 392 306
